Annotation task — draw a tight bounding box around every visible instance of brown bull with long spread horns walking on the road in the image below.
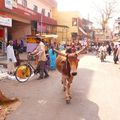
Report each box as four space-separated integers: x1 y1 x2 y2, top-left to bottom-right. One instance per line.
54 46 87 104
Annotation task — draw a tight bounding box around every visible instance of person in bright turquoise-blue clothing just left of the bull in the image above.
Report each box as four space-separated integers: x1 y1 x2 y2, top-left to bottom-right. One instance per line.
48 46 56 70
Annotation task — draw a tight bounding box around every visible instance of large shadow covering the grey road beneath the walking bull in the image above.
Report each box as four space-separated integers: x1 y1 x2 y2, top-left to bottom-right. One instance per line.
0 68 100 120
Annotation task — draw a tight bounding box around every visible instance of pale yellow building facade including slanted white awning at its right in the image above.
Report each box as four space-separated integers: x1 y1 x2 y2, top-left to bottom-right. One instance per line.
57 11 87 42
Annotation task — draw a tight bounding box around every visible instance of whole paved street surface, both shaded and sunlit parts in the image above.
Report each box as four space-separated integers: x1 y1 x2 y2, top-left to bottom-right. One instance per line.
0 55 120 120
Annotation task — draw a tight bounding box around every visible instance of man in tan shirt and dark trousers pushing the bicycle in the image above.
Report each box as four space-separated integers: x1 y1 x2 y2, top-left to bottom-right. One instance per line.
31 38 49 79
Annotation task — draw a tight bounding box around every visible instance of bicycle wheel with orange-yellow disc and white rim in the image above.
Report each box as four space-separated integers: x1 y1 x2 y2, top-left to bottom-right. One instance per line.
15 65 32 83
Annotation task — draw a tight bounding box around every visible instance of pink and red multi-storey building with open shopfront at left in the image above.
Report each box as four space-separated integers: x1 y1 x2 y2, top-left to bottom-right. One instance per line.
0 0 57 54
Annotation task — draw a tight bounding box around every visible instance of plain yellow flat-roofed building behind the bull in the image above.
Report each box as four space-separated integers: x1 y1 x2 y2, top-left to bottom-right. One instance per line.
54 11 80 42
